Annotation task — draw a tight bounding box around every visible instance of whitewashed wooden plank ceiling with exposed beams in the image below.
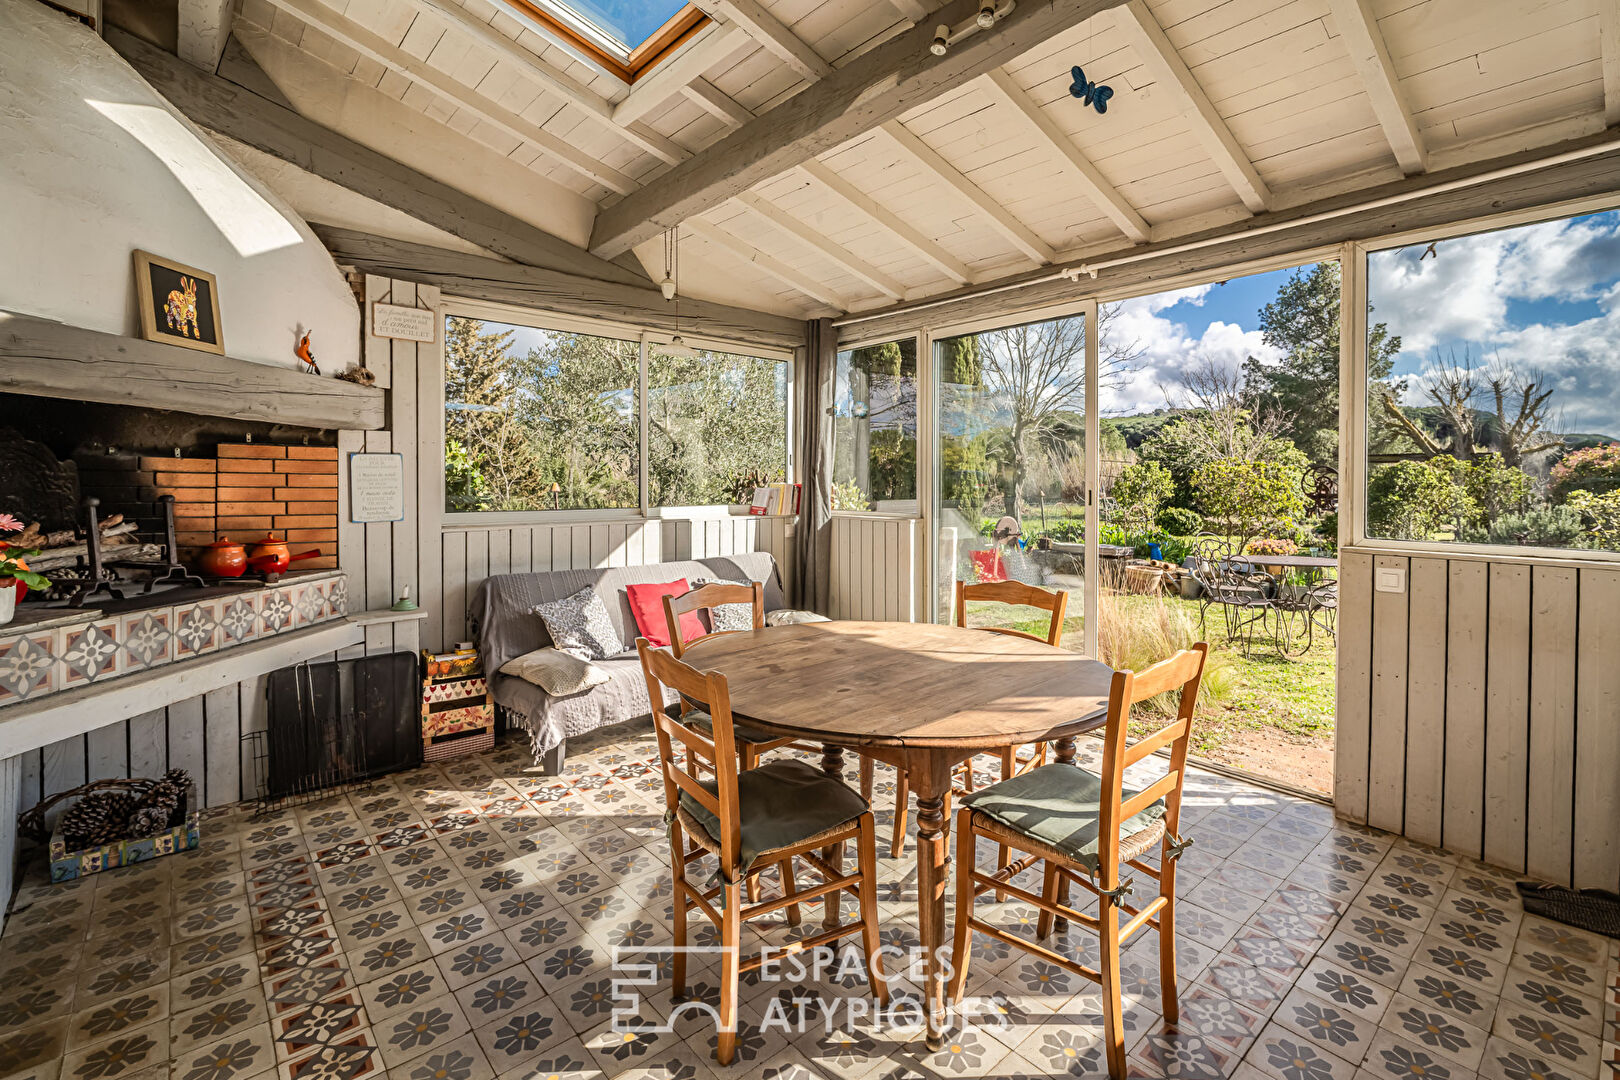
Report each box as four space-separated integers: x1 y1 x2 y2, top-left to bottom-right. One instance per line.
208 0 1620 316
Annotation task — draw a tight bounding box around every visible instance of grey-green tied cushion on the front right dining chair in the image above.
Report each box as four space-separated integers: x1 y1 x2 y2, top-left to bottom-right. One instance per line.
962 764 1165 871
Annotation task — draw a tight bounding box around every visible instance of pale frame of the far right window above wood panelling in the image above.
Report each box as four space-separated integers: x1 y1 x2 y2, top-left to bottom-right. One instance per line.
1338 193 1620 567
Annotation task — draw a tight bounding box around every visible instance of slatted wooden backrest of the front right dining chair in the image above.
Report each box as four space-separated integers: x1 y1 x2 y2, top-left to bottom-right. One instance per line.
1097 641 1210 889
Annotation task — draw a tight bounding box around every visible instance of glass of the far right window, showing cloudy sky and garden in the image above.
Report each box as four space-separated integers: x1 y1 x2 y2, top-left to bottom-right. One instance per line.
1366 210 1620 551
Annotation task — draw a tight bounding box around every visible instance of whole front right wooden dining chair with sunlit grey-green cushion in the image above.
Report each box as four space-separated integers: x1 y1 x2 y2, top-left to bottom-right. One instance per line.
949 641 1209 1080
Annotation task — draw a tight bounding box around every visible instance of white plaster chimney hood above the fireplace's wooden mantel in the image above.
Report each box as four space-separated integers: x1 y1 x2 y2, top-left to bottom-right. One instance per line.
0 0 360 372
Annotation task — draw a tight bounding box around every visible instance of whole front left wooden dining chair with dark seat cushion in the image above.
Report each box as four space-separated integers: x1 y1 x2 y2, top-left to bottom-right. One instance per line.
635 638 888 1065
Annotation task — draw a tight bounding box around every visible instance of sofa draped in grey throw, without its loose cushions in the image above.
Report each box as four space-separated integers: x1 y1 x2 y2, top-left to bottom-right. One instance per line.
468 552 786 772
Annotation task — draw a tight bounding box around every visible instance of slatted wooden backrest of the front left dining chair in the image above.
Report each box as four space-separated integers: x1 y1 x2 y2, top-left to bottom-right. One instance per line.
635 638 742 876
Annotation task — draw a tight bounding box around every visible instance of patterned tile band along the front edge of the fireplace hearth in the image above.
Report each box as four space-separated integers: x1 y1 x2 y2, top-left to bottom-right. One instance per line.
0 570 348 709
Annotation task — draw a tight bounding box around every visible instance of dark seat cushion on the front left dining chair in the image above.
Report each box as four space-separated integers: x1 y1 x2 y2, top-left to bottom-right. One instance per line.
680 761 867 868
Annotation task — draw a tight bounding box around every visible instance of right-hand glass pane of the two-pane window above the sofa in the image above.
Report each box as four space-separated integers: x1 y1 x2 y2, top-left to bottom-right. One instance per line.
646 345 787 507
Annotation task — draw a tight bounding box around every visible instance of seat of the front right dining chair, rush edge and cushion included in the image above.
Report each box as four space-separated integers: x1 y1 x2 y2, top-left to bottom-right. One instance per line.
962 764 1165 873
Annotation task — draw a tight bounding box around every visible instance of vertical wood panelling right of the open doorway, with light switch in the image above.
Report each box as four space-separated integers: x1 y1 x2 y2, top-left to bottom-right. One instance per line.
1335 549 1620 889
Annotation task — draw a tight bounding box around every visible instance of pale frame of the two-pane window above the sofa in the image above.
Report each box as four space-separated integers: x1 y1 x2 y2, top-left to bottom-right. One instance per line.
434 296 799 528
